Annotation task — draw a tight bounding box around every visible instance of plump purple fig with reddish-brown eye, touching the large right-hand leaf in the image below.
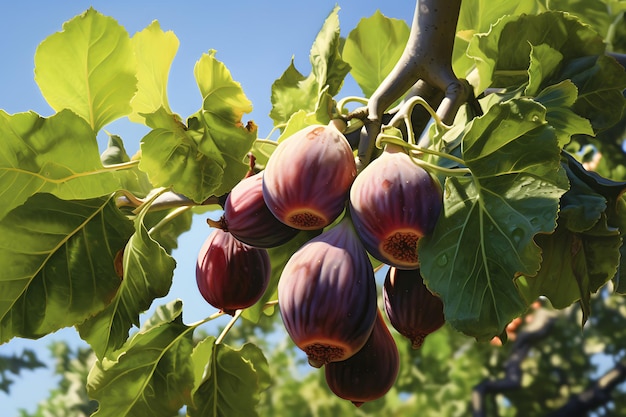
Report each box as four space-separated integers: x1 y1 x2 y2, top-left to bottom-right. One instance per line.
349 145 443 269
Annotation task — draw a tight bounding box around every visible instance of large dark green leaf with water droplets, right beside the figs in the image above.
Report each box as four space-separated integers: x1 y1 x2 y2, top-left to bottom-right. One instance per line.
419 99 567 340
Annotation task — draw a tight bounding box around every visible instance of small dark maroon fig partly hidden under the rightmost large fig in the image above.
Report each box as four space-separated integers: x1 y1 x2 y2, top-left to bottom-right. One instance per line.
383 268 446 349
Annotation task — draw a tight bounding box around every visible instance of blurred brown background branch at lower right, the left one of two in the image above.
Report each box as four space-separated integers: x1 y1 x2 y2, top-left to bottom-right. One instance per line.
472 308 557 417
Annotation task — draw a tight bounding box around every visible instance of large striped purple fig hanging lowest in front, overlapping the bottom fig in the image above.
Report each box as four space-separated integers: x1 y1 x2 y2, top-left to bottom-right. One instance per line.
278 217 377 368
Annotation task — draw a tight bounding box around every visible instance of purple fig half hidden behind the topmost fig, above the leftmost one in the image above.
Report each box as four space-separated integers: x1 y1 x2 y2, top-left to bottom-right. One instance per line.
223 172 298 248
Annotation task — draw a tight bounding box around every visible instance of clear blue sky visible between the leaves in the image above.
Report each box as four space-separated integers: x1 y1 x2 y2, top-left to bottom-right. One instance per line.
0 0 414 417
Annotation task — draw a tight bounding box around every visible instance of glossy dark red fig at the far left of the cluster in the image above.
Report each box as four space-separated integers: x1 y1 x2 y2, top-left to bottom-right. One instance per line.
196 229 271 315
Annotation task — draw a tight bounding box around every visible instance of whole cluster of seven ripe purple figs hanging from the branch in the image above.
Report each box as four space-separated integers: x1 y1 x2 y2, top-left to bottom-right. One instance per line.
196 123 445 406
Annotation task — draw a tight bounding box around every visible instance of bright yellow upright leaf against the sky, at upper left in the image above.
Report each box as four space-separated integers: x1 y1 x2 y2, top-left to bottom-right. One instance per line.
128 20 179 123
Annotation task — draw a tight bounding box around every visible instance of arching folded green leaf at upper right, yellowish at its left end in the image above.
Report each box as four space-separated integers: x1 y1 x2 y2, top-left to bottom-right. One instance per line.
467 12 605 92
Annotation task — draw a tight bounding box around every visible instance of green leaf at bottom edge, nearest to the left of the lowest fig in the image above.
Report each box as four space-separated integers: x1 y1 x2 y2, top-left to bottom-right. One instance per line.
187 337 270 417
